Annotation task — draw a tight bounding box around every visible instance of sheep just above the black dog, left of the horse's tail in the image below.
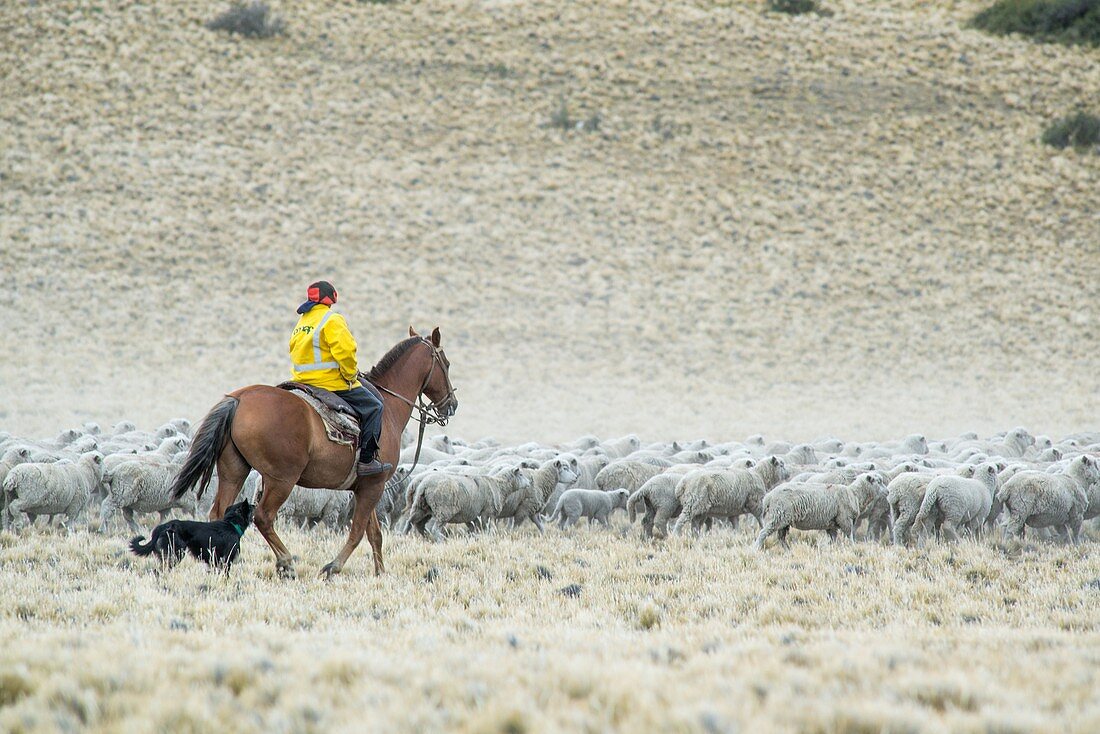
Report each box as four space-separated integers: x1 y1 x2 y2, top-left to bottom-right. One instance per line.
99 457 198 533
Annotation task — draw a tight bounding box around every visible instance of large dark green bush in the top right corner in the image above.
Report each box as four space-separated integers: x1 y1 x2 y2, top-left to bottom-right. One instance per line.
971 0 1100 46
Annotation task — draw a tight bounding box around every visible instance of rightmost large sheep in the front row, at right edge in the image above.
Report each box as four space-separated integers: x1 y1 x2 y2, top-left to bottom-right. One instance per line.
998 456 1100 543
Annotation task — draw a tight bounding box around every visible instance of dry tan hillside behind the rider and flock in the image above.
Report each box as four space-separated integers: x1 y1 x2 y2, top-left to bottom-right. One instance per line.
0 1 1100 441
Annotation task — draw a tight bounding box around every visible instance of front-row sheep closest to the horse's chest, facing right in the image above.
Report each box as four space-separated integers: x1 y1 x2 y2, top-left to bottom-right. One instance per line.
408 467 531 539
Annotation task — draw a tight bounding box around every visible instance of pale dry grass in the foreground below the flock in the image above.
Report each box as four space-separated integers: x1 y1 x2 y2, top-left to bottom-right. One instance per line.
0 525 1100 732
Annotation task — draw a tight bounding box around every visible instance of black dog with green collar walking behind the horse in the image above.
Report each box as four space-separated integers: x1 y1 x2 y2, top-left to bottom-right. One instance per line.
130 500 253 573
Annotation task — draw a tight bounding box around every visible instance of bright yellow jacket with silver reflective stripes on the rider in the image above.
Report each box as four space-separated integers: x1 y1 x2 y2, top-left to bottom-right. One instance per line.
290 305 360 391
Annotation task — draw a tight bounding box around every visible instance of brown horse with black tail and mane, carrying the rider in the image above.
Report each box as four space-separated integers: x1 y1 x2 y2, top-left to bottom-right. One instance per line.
172 327 459 578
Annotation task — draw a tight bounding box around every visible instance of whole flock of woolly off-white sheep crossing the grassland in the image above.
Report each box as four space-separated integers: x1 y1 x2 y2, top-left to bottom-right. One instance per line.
0 418 1100 548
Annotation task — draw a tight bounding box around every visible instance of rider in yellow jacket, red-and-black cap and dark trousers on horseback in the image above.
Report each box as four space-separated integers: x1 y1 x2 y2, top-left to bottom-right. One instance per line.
290 281 394 476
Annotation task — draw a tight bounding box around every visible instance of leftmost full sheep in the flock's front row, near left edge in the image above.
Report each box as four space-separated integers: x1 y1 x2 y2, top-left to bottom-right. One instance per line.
3 453 103 528
